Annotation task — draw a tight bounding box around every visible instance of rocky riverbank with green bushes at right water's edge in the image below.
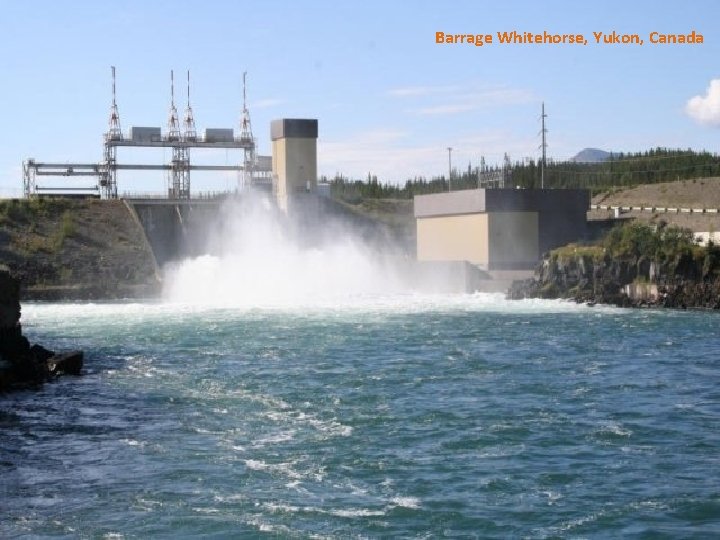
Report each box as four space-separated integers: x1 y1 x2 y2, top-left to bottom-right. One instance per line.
507 223 720 309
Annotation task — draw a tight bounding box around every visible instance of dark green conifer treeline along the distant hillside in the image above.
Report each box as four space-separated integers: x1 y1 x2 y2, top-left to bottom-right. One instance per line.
321 148 720 202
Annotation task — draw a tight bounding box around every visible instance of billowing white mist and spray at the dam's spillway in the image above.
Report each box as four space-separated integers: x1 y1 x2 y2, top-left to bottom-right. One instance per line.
163 191 413 307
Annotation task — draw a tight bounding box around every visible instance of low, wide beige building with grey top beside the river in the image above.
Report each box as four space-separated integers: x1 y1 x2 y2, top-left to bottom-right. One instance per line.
414 189 590 270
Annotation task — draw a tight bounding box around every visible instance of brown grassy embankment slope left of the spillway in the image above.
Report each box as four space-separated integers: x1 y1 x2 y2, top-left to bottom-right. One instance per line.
0 199 159 300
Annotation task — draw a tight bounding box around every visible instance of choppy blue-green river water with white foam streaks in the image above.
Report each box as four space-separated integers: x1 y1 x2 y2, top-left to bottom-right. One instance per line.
0 295 720 538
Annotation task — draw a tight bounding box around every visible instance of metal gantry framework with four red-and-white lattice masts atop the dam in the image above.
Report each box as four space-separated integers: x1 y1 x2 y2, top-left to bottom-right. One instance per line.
23 66 272 199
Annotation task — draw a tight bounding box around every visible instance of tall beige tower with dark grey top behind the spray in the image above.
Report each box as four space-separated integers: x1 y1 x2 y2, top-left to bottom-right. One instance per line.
270 118 318 212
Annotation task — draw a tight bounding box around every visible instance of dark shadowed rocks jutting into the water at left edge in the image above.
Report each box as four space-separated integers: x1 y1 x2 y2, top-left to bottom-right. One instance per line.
0 265 83 393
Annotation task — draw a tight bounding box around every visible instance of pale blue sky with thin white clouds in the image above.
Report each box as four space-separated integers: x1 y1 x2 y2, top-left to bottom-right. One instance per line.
0 0 720 197
